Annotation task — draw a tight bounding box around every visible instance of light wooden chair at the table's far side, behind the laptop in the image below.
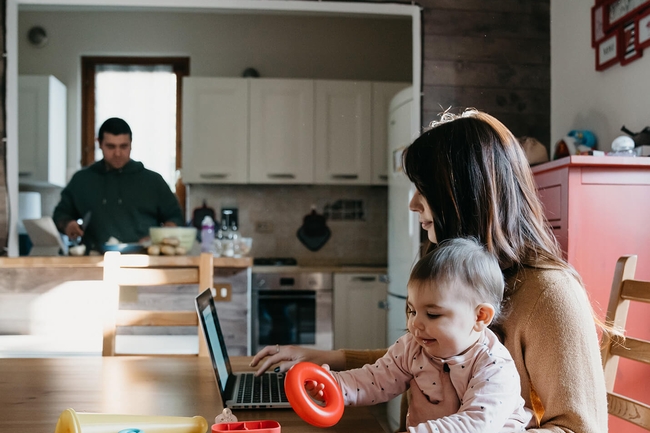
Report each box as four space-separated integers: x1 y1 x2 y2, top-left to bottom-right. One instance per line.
102 251 214 356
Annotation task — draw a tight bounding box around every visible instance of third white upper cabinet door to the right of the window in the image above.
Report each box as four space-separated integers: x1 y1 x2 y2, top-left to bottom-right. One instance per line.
314 80 372 185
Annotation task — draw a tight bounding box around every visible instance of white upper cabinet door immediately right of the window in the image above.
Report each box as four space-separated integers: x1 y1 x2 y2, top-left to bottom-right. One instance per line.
182 77 249 184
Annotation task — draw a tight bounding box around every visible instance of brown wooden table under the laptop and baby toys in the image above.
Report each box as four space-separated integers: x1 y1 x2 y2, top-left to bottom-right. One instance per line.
0 356 383 433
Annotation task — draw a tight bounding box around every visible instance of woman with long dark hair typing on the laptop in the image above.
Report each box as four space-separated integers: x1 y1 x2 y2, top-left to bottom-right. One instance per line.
251 110 607 433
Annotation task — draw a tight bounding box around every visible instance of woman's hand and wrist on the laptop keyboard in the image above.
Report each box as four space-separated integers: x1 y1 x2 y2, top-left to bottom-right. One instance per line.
250 344 345 376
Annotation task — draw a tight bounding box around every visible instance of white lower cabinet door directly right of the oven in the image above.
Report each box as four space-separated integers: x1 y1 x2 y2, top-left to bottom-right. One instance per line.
334 273 387 349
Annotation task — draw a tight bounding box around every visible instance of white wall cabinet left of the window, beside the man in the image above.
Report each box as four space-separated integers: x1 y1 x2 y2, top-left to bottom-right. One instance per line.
18 75 67 186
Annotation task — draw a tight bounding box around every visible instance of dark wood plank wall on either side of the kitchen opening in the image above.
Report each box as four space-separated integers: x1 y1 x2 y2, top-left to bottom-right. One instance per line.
0 0 551 251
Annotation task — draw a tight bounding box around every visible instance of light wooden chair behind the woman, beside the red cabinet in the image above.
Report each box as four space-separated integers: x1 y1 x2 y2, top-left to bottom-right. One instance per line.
601 256 650 431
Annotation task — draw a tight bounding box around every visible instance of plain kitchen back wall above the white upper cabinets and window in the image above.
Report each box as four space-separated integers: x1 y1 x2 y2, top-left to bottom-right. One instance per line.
18 11 413 176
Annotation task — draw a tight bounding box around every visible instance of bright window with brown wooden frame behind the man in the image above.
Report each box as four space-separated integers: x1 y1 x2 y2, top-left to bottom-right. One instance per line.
81 57 189 189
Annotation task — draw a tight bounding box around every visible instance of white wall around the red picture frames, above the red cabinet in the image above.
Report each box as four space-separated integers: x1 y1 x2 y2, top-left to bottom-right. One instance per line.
551 0 650 151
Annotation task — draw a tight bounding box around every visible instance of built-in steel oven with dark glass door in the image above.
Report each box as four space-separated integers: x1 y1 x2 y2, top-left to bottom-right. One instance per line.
251 268 334 353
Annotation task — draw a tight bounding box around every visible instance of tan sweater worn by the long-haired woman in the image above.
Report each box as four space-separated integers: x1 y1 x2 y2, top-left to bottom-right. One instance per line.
345 268 607 433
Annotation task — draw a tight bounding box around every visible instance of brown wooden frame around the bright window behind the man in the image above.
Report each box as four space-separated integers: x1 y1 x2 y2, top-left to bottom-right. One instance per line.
81 56 190 169
